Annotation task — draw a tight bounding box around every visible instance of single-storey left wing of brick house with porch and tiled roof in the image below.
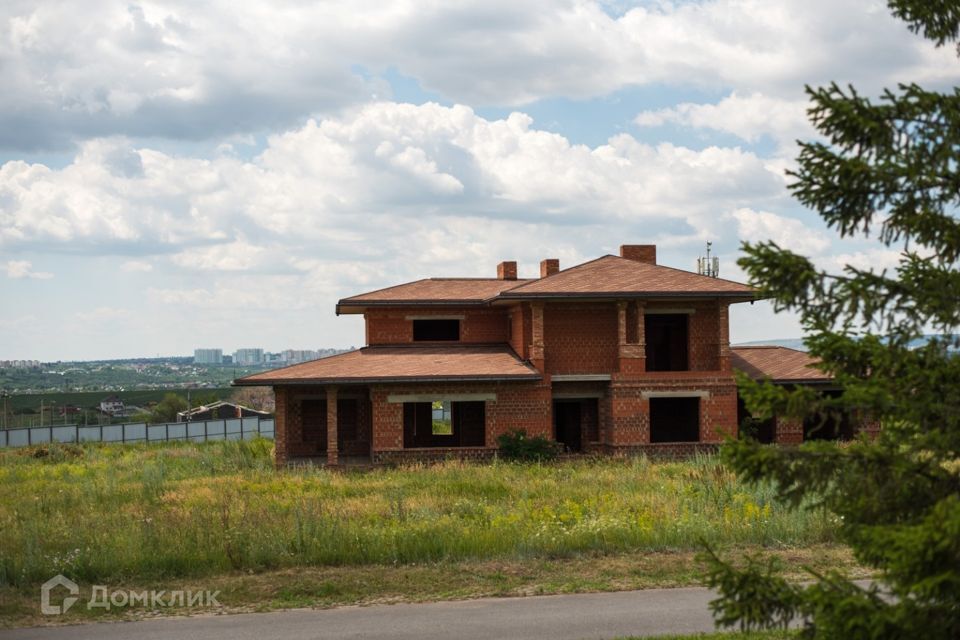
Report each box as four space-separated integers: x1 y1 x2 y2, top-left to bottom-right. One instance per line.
235 345 550 466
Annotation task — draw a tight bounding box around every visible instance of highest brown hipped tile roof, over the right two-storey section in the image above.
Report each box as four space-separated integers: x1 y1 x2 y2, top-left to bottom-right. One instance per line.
500 255 755 300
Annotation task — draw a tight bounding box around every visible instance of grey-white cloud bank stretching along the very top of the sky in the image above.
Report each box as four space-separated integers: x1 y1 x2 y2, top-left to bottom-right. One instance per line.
0 0 958 149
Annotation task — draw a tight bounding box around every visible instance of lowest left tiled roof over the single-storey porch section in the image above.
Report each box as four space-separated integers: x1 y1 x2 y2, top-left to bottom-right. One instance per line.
234 345 541 385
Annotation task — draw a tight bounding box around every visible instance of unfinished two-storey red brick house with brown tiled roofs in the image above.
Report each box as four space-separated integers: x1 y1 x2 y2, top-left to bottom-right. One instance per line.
235 245 848 464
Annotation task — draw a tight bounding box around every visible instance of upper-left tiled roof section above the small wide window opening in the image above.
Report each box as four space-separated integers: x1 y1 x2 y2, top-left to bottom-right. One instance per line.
337 278 530 314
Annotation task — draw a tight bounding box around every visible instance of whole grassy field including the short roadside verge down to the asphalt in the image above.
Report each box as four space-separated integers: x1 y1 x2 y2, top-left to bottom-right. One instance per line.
0 440 869 626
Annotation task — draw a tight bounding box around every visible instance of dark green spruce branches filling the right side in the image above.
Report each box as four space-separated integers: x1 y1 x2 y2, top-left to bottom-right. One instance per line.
706 0 960 639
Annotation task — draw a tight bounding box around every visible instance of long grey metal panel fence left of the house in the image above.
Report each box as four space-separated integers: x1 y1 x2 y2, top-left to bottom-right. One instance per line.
0 417 273 447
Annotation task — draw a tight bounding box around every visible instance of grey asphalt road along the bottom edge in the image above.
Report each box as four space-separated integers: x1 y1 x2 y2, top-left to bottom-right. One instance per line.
0 588 728 640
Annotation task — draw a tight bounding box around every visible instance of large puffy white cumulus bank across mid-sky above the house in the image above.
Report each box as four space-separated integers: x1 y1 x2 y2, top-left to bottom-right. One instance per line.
0 103 784 272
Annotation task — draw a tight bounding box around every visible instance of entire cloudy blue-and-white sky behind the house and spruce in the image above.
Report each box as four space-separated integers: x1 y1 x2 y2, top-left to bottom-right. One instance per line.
0 0 960 360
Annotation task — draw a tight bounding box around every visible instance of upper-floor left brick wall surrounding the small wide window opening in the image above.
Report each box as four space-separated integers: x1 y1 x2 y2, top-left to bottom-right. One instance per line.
365 307 507 345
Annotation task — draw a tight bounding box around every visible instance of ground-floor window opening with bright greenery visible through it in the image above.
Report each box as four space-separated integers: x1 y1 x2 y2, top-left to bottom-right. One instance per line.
403 400 486 449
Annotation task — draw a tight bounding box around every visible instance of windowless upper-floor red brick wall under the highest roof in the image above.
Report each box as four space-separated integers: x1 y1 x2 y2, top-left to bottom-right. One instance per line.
543 302 619 374
